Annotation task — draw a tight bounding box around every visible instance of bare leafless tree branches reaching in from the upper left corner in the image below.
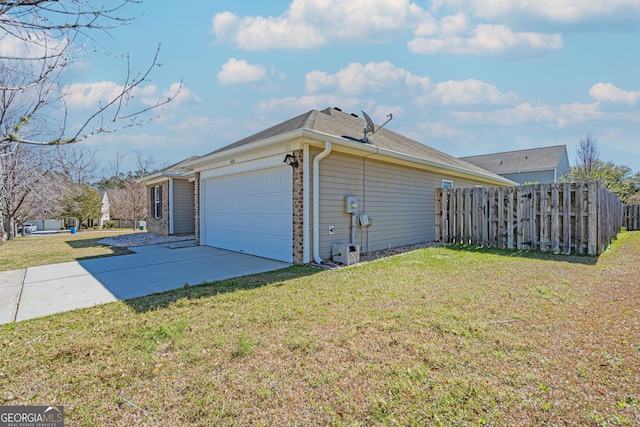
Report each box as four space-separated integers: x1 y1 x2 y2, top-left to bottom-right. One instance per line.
0 0 181 242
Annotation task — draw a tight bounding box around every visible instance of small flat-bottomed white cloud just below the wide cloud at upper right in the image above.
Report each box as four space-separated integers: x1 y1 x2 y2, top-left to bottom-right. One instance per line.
417 79 518 106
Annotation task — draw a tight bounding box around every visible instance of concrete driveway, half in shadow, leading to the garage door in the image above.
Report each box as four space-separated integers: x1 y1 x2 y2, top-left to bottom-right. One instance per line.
0 243 290 324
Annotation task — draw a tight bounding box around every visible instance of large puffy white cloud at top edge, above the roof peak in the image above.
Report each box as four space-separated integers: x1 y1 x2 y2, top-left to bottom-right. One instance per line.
213 0 424 50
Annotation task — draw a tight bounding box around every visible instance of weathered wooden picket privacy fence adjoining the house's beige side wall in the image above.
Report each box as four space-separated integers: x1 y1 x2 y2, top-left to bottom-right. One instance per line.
436 183 624 255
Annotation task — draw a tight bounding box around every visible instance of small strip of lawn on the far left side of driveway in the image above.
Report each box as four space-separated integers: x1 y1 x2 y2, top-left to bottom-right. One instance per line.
0 229 132 271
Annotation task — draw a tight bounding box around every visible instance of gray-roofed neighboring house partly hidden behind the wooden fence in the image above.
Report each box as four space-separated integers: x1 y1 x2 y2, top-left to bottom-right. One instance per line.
460 145 570 184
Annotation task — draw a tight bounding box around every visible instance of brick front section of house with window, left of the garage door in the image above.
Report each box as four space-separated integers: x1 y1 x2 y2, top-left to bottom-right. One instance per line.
140 156 198 236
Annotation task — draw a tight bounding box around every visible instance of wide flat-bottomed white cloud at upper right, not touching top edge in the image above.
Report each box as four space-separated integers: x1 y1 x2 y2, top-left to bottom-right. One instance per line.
407 24 563 56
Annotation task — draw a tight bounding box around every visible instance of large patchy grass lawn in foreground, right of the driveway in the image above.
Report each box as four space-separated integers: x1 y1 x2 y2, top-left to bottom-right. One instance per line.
0 232 640 426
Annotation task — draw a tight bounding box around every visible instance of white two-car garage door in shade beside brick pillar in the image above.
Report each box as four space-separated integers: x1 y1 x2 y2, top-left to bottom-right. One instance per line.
203 166 293 262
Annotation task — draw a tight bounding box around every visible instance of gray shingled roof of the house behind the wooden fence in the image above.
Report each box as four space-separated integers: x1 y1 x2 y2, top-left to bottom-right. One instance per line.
460 145 567 174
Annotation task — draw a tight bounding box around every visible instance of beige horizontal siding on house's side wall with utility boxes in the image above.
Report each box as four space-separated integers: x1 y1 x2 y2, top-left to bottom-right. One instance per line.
310 150 500 259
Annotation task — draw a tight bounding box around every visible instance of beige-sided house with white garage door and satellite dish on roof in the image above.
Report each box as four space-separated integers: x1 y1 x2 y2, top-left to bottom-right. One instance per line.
143 108 514 263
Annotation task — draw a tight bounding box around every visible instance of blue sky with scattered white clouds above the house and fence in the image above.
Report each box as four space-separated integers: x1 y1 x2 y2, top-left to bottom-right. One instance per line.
58 0 640 172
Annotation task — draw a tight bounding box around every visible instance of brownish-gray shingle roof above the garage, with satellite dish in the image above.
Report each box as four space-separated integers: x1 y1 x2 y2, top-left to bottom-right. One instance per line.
202 108 499 178
